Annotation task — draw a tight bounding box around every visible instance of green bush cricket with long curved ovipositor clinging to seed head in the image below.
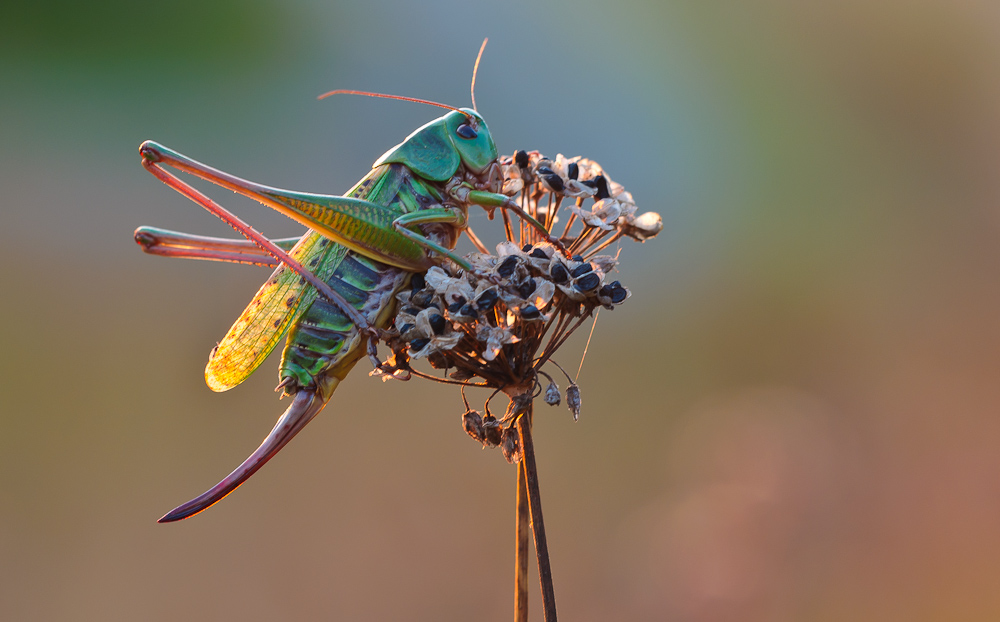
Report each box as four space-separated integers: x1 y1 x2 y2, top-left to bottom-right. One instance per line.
135 58 562 522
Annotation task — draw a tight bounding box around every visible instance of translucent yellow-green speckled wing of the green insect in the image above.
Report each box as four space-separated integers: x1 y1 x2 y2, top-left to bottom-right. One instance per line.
205 231 347 391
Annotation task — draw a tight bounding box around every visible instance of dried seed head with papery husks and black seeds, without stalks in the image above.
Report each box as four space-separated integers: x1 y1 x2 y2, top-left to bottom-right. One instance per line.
383 151 663 462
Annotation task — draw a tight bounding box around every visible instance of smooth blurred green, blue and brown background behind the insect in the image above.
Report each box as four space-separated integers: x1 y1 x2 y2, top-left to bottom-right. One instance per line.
0 0 1000 621
